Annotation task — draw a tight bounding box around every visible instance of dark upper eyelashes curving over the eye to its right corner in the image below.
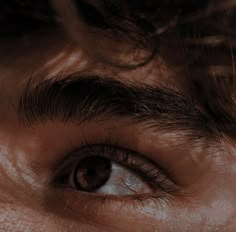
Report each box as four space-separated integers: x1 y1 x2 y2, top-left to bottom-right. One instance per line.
54 137 177 193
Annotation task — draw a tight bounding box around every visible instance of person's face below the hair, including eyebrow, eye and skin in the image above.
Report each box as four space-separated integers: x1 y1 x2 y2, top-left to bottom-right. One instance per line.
0 16 236 232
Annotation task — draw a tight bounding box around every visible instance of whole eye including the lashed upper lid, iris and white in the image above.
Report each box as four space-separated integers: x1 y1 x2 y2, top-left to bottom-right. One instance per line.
56 144 176 195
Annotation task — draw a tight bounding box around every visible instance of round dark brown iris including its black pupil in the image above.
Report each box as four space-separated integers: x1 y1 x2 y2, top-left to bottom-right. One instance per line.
74 156 111 192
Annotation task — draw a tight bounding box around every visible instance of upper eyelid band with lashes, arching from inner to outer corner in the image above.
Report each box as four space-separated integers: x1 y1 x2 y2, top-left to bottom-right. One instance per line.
54 137 177 196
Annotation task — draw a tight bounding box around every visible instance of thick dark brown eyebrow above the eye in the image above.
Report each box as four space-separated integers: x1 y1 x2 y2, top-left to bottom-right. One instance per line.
18 76 214 136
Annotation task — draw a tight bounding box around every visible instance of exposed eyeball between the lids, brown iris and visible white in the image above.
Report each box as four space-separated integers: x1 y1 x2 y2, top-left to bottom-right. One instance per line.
70 156 152 195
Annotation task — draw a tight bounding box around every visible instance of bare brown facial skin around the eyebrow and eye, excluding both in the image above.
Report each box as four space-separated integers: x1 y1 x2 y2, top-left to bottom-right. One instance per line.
0 25 236 232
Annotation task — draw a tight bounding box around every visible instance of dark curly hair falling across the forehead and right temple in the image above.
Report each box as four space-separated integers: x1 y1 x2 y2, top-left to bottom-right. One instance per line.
0 0 236 136
